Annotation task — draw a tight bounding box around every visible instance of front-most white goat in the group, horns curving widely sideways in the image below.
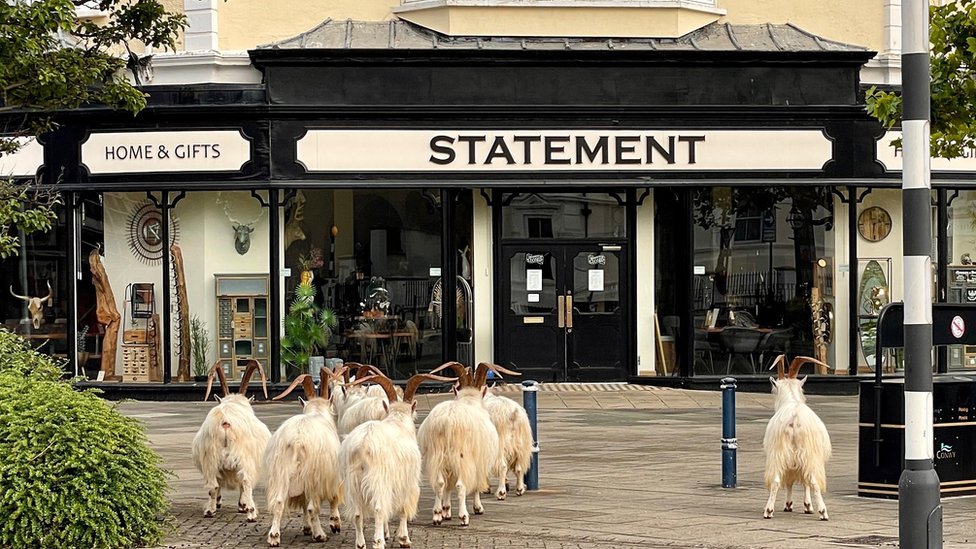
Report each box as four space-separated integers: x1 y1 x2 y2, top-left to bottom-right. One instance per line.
339 374 454 549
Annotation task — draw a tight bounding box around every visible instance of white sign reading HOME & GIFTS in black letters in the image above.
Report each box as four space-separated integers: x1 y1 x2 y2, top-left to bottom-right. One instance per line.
81 130 251 174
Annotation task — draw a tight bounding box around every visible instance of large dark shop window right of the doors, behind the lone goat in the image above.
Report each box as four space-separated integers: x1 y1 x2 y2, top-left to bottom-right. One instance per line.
692 187 847 375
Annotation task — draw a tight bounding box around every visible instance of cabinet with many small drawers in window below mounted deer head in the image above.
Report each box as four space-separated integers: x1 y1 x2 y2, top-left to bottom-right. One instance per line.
214 274 270 379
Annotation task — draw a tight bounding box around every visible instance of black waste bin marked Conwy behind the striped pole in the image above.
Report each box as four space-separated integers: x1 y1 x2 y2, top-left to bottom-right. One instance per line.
857 374 976 499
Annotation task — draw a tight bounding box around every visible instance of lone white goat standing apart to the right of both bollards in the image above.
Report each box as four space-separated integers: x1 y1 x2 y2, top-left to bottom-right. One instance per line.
763 355 831 520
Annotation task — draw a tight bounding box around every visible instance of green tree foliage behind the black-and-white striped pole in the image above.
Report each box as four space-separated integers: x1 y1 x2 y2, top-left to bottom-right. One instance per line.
865 0 976 158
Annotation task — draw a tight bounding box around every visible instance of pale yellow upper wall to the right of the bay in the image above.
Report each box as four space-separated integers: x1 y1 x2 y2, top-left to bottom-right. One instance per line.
718 0 884 51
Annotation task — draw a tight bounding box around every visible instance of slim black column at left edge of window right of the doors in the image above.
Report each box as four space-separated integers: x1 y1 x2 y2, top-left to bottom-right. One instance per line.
674 187 695 377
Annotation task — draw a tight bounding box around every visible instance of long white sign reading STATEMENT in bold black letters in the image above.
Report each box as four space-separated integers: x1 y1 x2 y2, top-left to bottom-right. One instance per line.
297 129 833 172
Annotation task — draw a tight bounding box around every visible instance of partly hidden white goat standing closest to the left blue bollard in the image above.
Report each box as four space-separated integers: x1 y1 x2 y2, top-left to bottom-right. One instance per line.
484 378 532 500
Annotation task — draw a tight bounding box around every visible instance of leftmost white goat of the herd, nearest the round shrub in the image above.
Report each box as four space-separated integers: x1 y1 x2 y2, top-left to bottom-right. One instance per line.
192 360 271 522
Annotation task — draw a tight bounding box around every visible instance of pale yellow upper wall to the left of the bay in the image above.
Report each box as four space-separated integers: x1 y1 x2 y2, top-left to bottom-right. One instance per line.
217 0 400 50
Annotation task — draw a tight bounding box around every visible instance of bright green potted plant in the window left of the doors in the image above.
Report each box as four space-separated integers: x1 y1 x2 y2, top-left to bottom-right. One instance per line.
281 281 338 379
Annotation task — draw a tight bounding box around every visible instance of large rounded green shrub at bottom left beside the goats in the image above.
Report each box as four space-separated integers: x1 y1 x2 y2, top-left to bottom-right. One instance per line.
0 335 168 549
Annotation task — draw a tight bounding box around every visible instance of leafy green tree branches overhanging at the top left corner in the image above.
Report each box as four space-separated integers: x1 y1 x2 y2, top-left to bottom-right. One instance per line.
0 0 186 259
